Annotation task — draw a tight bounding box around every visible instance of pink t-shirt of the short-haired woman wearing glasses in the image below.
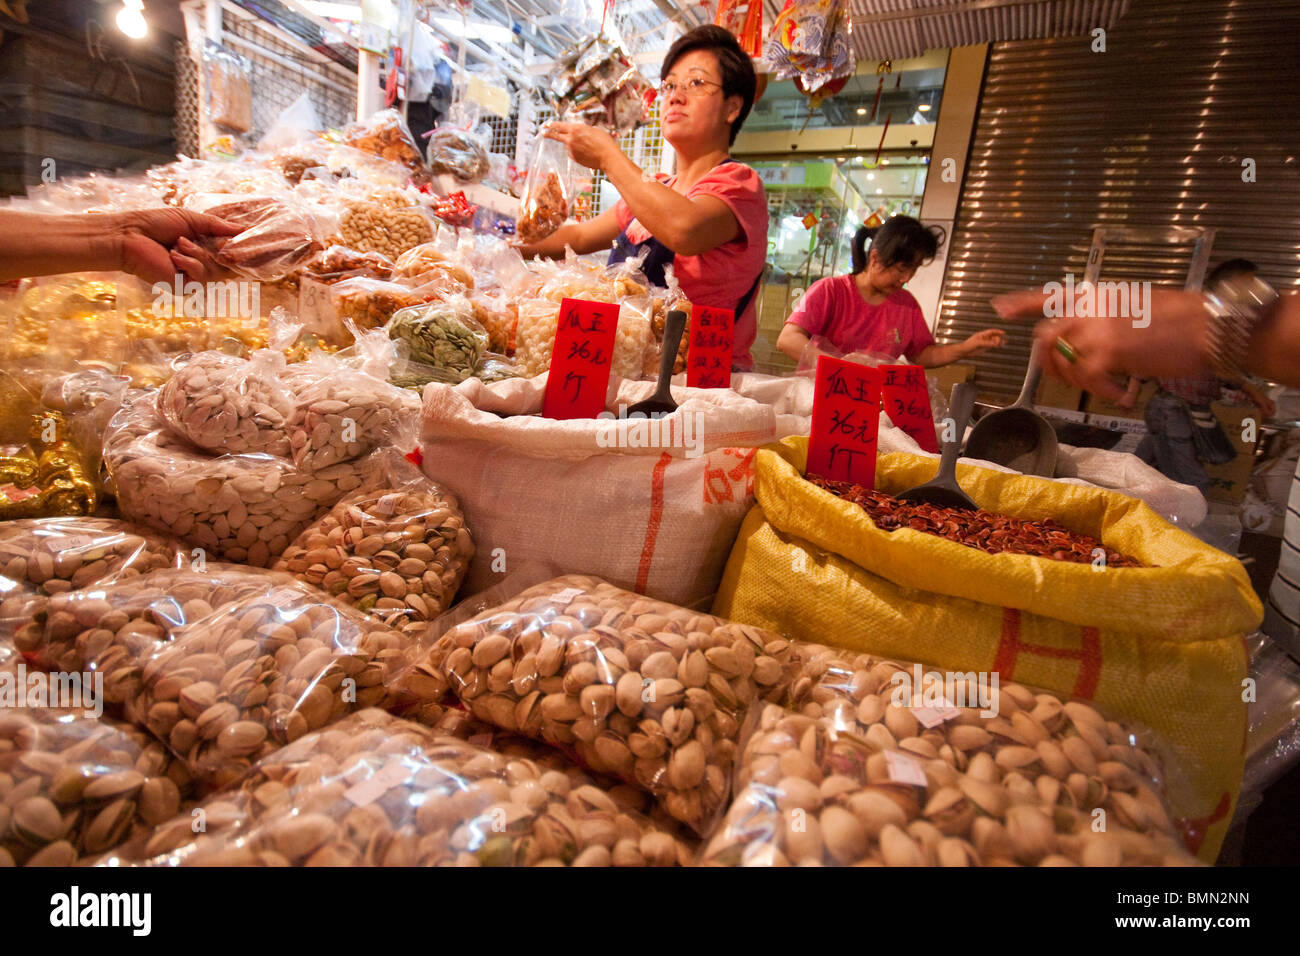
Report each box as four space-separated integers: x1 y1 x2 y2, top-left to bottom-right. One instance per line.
615 163 767 371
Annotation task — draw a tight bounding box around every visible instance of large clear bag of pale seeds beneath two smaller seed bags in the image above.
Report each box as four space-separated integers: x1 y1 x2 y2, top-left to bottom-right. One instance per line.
104 386 366 567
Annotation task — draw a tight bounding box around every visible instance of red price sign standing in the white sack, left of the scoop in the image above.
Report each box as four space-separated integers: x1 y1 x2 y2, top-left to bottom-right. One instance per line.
542 299 619 419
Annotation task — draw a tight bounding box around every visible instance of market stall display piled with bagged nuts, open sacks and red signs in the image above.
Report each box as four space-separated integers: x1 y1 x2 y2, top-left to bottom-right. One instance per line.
0 3 1300 866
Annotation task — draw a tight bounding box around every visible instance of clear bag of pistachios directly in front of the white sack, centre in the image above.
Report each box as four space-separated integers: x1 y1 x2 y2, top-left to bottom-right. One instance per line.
399 575 789 832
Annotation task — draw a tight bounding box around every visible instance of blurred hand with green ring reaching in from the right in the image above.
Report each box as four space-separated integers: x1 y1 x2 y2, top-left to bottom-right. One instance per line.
992 289 1213 401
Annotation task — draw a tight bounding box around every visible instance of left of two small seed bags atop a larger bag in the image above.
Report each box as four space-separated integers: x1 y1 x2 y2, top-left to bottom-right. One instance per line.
157 349 294 458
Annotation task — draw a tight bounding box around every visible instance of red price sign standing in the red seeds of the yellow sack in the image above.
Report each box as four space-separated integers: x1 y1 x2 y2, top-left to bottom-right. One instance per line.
806 355 881 488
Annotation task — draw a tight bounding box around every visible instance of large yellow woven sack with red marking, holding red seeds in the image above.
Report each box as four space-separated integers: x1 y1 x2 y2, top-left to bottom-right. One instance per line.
714 437 1262 861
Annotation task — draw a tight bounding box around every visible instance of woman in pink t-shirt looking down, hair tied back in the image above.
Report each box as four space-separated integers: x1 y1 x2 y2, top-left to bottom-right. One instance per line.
776 216 1005 368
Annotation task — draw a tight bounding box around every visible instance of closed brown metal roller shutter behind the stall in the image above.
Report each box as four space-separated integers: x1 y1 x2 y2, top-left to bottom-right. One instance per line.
936 0 1300 399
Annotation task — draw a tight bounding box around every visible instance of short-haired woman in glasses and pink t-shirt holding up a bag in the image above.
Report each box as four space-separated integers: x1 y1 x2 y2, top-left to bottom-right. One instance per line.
519 26 767 371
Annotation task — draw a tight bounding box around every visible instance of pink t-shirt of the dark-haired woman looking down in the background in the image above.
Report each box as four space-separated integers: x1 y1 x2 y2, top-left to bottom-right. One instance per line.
785 276 935 359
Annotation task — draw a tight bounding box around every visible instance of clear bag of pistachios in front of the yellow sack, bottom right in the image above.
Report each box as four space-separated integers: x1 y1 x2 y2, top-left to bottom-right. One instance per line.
701 643 1197 866
